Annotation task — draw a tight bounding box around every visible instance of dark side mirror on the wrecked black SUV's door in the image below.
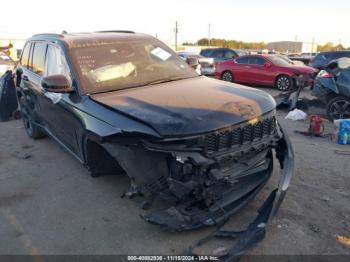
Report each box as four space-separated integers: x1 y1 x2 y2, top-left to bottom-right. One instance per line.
41 75 74 93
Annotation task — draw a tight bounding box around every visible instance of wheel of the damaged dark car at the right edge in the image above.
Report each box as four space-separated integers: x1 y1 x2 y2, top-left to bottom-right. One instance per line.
327 96 350 121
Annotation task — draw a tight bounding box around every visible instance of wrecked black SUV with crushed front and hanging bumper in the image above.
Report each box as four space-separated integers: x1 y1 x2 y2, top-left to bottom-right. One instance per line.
16 31 293 258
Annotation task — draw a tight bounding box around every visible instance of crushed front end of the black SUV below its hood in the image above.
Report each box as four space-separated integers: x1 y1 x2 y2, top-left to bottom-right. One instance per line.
105 111 293 234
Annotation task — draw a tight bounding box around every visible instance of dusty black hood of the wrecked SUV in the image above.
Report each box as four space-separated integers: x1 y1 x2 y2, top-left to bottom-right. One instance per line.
90 77 276 136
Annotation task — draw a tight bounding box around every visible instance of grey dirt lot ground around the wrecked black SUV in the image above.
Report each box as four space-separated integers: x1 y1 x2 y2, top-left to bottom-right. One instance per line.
0 89 350 255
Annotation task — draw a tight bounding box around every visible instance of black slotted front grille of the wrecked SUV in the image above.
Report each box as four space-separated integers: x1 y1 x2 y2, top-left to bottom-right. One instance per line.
204 117 276 153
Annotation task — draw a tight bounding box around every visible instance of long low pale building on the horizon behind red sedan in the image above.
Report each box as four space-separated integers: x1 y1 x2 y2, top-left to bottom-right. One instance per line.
267 41 317 54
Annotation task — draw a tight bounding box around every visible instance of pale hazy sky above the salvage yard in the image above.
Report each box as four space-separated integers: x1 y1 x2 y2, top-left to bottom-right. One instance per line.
0 0 350 46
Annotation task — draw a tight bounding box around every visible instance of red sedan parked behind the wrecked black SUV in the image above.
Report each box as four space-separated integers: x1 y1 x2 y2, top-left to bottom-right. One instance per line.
215 55 317 91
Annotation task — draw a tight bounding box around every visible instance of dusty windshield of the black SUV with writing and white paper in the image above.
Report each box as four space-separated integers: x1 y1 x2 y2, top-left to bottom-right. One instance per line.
70 38 198 93
